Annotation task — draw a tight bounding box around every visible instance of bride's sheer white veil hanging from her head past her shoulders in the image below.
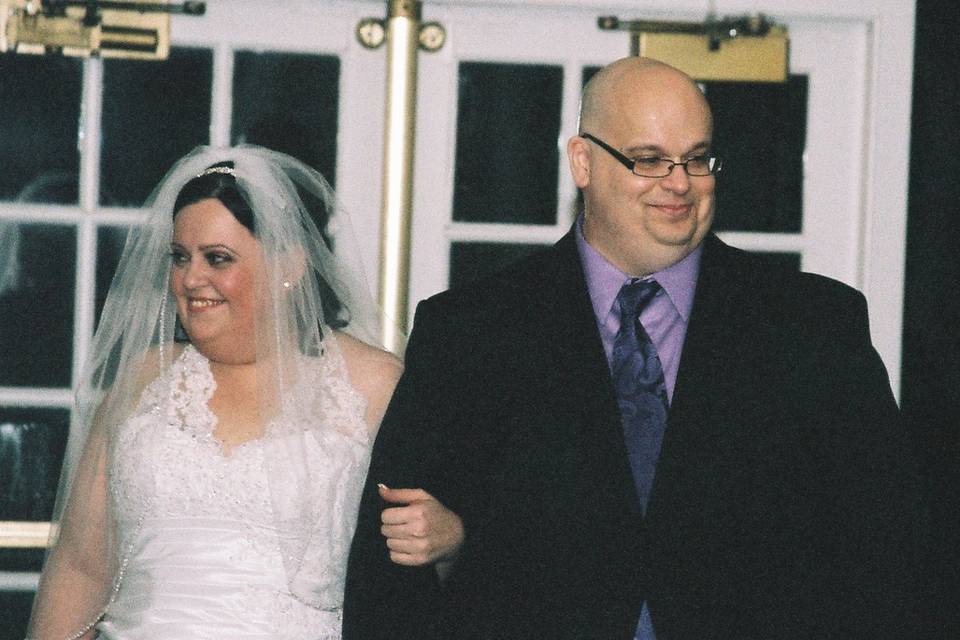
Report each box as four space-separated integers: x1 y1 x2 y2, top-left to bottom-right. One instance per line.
28 145 399 638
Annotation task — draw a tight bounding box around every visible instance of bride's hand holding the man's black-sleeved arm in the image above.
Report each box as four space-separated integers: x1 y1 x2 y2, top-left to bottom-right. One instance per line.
380 485 464 567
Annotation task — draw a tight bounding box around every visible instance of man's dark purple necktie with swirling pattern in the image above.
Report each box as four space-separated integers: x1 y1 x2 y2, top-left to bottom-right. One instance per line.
610 280 668 640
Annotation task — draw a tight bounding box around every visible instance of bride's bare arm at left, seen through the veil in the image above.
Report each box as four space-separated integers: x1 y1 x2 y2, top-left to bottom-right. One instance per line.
27 416 110 640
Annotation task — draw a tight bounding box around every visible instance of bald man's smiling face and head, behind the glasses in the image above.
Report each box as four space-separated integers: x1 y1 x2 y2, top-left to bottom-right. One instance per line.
571 61 716 276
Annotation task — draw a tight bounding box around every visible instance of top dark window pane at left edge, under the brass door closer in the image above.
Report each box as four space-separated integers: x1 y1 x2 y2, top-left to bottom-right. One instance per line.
0 54 82 203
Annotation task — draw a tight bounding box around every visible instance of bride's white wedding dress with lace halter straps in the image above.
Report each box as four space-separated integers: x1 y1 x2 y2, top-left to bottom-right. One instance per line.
96 338 369 640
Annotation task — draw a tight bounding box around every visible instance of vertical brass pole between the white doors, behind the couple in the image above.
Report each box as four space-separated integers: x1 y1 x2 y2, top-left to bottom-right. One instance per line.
379 0 421 351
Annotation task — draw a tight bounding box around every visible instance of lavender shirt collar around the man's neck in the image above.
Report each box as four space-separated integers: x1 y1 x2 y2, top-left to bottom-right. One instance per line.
575 214 703 322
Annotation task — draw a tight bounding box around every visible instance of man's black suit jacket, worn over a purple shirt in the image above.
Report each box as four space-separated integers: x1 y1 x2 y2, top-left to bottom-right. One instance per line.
344 233 918 640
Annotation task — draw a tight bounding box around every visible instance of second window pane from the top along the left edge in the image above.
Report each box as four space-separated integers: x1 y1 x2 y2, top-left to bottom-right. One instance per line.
0 221 76 387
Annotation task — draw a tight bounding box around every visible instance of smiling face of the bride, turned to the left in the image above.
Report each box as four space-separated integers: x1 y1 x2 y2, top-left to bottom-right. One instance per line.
170 198 262 364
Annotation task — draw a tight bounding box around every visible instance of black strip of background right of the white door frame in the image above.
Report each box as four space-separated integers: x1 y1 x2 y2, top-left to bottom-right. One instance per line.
901 0 960 638
